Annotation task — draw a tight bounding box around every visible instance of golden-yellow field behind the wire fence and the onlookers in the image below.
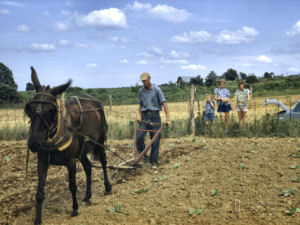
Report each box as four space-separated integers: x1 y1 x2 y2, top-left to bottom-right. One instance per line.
0 95 300 128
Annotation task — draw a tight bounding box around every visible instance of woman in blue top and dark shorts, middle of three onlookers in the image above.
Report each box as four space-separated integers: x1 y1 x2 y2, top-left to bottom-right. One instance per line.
214 79 232 128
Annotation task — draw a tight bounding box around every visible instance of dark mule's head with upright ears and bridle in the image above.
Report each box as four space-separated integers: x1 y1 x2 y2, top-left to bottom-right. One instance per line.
24 67 72 152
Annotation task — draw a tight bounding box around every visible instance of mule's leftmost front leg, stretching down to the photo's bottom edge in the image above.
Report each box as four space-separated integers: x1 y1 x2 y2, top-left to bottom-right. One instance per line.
34 155 48 225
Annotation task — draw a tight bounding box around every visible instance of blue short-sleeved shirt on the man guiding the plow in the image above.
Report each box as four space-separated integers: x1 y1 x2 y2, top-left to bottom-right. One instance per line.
139 84 166 111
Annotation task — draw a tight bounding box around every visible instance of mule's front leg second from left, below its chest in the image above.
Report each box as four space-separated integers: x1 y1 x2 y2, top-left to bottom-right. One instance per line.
68 158 78 216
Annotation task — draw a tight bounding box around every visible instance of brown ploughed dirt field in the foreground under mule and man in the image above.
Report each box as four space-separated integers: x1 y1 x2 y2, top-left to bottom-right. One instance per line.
0 137 300 225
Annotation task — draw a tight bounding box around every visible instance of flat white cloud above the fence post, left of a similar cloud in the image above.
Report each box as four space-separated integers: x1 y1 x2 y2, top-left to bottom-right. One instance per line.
171 30 212 43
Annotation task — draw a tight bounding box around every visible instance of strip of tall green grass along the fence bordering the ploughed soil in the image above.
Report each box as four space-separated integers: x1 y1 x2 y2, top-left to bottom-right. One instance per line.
0 114 300 141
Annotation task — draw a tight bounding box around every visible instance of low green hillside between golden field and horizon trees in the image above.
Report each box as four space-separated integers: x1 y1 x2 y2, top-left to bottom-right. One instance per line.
14 75 300 105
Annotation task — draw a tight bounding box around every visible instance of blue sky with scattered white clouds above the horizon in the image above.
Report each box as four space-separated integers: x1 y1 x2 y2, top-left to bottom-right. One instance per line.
0 0 300 90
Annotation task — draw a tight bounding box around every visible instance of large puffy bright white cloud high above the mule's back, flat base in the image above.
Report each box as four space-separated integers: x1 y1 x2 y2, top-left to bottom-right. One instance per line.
77 8 127 28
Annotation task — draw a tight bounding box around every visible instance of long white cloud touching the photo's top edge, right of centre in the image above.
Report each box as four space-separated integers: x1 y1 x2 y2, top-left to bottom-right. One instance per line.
127 1 190 23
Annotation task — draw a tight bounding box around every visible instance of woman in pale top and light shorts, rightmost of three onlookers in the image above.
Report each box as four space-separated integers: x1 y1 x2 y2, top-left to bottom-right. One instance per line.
232 80 250 125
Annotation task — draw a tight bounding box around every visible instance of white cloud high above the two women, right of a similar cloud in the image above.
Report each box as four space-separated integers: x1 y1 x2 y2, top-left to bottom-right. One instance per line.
216 26 259 44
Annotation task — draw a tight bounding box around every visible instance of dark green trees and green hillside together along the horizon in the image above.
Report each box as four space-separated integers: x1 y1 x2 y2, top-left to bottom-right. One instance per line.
0 63 300 106
